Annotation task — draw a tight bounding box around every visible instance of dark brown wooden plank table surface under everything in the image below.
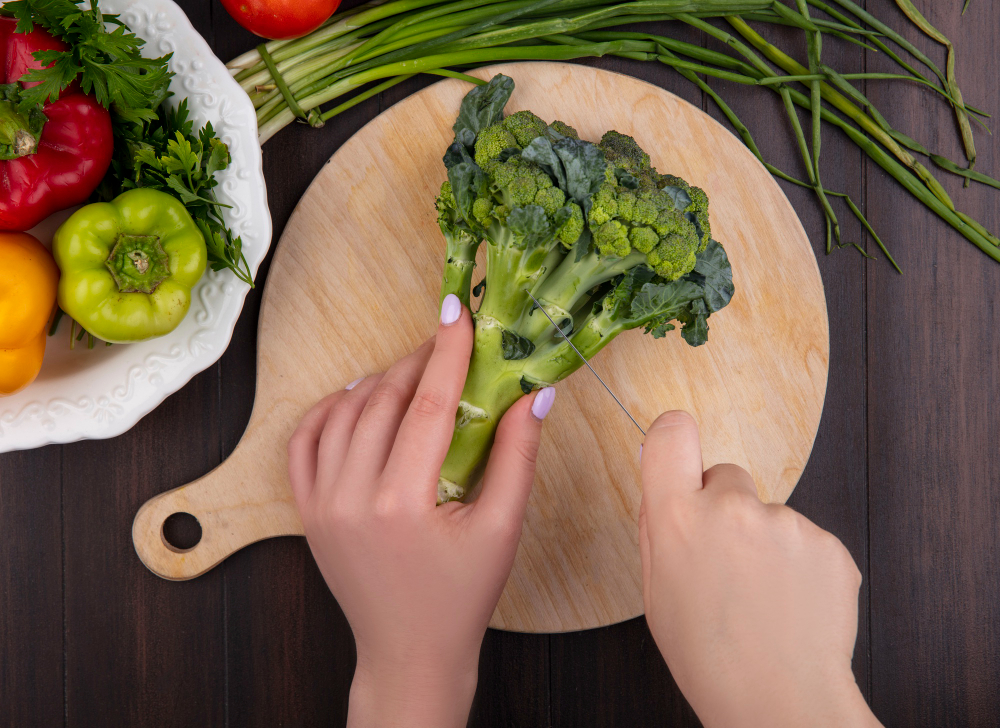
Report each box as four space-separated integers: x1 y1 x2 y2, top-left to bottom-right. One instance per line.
0 0 1000 728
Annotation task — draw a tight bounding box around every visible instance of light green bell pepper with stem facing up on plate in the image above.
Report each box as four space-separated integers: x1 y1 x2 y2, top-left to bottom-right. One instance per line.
52 188 208 343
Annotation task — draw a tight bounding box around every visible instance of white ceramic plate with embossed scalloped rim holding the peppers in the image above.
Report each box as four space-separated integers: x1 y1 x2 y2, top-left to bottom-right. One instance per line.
0 0 271 452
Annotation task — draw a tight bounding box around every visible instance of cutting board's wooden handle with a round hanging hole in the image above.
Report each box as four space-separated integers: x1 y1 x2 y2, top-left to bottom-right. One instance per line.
132 423 303 581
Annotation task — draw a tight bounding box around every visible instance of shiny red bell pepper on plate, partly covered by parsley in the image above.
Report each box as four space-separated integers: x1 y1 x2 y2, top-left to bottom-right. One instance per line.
0 16 114 230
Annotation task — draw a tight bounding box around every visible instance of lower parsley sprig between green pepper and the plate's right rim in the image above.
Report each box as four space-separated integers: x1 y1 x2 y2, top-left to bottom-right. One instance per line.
96 99 253 288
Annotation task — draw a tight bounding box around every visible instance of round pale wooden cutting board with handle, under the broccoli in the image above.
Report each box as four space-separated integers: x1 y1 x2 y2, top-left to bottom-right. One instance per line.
133 63 829 632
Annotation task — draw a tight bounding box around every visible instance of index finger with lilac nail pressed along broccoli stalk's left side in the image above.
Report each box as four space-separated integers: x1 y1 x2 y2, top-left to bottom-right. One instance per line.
387 294 472 504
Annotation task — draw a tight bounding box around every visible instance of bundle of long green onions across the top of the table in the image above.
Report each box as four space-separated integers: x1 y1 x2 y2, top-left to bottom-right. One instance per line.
229 0 1000 270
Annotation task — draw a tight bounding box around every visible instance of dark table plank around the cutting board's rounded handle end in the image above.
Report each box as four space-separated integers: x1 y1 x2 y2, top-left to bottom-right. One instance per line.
63 371 226 728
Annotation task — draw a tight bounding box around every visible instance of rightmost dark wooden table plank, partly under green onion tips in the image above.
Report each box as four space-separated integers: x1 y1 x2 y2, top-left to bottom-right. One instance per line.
868 0 1000 728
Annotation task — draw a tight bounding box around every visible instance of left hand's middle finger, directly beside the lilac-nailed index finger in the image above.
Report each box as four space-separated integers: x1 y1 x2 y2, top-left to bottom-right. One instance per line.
344 338 434 482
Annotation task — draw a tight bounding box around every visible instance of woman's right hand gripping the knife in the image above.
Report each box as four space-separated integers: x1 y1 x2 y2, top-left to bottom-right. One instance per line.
639 412 879 728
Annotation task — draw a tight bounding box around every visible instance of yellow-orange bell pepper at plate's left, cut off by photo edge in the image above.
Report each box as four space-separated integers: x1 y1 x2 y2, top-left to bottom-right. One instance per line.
0 233 59 397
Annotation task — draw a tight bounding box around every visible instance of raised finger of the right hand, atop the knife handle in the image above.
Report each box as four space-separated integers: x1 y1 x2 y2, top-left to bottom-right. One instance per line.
641 410 704 505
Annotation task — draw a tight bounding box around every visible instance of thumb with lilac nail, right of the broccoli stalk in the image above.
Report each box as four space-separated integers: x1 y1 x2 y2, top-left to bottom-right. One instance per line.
473 387 556 531
